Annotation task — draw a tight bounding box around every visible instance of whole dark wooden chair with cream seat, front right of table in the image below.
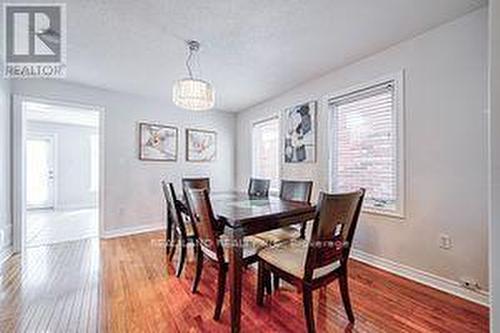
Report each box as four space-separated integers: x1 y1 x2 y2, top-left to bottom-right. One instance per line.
257 189 365 332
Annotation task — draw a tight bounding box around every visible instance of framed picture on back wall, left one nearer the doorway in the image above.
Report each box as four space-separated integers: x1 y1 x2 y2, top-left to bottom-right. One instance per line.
139 123 179 161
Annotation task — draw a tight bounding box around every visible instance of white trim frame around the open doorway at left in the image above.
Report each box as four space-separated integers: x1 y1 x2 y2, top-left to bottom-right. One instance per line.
11 94 106 254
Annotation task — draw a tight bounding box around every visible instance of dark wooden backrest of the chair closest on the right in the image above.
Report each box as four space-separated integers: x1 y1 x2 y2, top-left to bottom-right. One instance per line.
304 189 365 280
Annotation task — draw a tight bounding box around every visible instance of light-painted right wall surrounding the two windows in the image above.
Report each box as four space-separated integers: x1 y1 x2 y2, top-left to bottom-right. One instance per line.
236 8 488 289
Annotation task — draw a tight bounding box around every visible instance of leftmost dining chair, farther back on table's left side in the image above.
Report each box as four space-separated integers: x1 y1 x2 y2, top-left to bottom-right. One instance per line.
161 181 195 277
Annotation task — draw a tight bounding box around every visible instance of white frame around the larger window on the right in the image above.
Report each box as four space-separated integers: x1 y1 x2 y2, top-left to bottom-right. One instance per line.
325 70 406 220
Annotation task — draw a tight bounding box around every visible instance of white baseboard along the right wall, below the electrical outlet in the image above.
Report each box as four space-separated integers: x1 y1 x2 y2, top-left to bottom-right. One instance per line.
352 249 490 306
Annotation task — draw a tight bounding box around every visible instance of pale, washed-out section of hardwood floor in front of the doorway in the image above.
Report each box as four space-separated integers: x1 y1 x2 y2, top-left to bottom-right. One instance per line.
0 239 100 332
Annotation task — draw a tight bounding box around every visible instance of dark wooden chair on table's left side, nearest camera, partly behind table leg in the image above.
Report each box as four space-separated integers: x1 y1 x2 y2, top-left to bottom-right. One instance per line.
185 189 270 320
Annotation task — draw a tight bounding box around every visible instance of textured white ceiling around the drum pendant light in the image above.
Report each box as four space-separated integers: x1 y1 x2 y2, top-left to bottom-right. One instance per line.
4 0 486 111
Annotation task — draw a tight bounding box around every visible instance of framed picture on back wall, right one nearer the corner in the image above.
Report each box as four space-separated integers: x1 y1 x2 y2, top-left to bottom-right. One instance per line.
186 128 217 162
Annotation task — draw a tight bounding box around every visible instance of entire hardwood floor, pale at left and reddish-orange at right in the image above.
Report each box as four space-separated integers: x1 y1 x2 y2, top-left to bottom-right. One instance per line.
0 232 488 333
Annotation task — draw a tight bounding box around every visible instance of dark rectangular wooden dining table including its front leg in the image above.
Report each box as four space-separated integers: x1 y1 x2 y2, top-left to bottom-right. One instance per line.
210 192 315 332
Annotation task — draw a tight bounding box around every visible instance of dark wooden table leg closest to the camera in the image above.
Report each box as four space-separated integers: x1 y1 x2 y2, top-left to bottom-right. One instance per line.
229 229 243 332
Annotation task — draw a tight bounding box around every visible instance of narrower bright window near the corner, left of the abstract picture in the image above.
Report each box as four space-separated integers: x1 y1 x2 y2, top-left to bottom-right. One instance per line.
252 117 279 189
